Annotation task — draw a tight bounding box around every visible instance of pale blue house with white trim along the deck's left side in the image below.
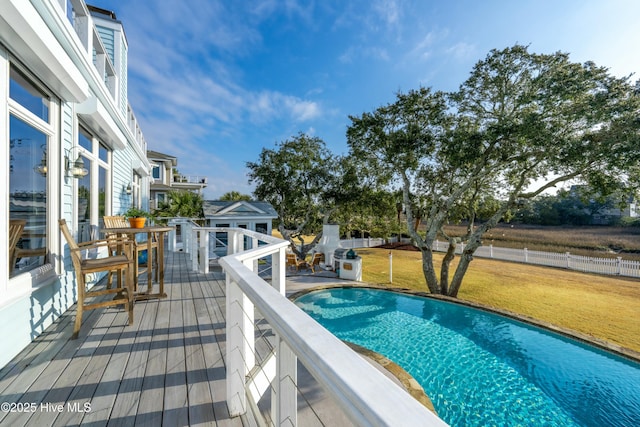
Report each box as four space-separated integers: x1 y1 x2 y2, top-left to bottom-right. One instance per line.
0 0 151 366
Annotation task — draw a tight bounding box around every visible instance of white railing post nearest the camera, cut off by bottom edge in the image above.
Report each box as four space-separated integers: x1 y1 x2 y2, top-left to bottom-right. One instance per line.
271 335 298 426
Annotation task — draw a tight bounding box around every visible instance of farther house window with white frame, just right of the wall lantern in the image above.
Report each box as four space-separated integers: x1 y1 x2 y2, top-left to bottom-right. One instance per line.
74 126 112 242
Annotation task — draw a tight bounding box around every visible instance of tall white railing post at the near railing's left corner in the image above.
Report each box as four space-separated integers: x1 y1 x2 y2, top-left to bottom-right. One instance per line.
226 276 255 417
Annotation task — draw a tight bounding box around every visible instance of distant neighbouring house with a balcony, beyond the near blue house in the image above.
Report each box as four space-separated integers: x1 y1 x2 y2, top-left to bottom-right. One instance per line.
147 150 207 209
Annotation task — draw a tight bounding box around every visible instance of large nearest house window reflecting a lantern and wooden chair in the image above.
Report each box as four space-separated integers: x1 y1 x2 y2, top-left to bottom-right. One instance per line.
5 64 54 277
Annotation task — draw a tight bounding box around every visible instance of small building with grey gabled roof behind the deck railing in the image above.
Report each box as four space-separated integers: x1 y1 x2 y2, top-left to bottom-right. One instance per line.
203 200 278 235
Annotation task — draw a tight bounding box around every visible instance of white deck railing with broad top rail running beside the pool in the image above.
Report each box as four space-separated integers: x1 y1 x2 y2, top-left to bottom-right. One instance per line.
175 222 446 426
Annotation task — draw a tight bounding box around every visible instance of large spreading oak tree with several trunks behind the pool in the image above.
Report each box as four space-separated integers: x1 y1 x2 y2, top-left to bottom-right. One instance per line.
347 45 640 297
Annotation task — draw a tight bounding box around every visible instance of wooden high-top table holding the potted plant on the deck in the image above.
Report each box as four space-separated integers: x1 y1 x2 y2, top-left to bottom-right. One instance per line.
100 225 175 300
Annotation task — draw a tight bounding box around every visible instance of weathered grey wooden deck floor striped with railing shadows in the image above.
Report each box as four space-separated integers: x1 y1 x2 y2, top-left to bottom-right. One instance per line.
0 252 255 427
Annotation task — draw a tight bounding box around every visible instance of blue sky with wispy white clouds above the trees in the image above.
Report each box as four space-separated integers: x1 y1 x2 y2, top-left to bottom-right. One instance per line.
89 0 640 199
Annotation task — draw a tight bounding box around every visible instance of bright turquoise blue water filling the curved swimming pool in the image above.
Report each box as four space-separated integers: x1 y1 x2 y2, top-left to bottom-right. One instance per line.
295 288 640 427
